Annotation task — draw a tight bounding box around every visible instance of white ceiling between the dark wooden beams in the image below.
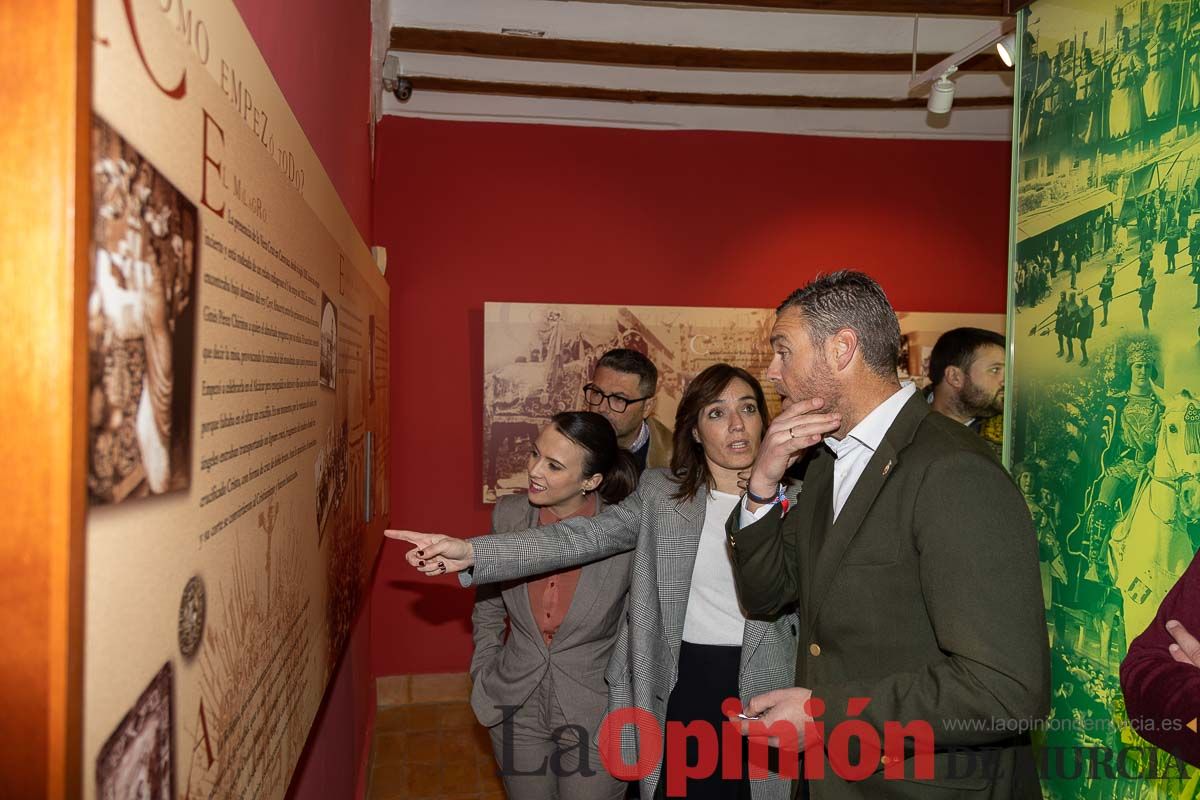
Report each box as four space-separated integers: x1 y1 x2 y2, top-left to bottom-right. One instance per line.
379 0 1013 139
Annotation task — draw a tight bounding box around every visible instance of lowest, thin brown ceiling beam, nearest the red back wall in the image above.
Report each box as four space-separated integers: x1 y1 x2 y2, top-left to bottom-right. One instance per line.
404 76 1013 110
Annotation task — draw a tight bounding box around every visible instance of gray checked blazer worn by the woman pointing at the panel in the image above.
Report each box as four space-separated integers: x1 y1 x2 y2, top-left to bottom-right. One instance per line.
460 469 798 800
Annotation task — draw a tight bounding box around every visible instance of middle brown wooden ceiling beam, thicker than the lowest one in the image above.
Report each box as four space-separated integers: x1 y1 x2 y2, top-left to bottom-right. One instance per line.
390 26 1007 73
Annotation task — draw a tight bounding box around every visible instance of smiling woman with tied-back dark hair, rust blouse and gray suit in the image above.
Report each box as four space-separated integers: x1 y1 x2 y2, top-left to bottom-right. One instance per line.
470 411 637 800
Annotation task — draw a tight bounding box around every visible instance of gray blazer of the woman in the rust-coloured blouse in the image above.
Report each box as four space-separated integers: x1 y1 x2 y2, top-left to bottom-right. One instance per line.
470 494 634 730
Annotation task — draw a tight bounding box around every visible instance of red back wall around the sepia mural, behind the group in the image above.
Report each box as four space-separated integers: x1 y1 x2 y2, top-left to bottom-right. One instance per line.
372 118 1009 675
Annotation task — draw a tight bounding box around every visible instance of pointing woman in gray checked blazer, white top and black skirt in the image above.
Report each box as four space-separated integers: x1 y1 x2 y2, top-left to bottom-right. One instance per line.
388 363 798 800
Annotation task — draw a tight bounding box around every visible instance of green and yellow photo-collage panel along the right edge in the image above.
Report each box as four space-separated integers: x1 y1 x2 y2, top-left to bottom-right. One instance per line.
1008 0 1200 800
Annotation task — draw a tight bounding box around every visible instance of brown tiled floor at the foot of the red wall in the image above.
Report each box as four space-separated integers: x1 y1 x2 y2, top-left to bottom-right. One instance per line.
368 675 504 800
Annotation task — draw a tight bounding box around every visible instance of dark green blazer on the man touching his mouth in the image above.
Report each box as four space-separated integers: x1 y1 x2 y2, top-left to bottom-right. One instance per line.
728 393 1050 800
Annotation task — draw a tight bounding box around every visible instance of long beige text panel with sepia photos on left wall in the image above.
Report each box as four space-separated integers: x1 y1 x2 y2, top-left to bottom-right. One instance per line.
83 1 389 798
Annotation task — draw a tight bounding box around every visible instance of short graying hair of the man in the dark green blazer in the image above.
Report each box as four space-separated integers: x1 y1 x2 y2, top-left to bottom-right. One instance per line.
775 270 900 378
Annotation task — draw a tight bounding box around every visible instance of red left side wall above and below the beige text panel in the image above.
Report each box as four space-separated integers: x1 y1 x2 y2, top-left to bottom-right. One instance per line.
234 0 376 800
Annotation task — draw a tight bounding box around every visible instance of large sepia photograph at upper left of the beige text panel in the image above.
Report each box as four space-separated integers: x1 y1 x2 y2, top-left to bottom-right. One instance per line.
88 116 198 505
